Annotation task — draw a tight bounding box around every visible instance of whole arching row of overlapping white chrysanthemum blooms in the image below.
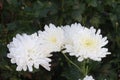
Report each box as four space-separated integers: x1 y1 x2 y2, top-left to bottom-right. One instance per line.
7 23 110 72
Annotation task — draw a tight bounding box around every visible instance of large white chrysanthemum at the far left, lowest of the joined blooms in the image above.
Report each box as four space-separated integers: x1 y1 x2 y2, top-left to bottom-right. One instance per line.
7 33 51 71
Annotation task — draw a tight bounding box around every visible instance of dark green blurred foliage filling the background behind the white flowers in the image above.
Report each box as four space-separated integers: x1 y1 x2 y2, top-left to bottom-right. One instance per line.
0 0 120 80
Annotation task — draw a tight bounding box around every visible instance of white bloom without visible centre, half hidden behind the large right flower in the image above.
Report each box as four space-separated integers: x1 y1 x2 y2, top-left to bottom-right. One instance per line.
62 23 83 54
